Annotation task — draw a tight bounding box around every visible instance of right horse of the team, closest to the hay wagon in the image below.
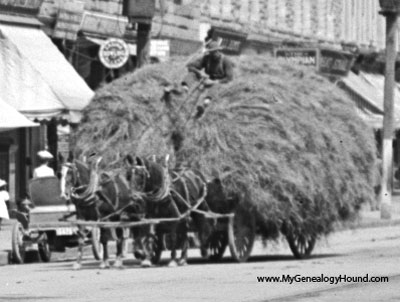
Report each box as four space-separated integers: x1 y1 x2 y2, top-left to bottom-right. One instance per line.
125 155 209 267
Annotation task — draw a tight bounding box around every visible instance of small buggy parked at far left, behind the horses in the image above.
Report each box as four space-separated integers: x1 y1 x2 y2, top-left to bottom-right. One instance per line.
11 177 78 263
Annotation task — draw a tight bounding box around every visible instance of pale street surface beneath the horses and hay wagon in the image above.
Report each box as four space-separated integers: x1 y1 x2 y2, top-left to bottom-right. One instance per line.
0 226 400 302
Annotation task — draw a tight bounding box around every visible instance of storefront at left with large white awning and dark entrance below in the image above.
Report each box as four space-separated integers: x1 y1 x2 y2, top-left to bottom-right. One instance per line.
0 15 93 200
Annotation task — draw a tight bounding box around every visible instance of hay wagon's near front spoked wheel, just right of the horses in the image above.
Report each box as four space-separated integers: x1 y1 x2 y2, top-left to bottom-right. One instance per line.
228 206 256 262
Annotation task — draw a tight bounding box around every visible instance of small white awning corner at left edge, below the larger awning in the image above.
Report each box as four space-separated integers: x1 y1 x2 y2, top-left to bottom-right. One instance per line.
0 100 39 132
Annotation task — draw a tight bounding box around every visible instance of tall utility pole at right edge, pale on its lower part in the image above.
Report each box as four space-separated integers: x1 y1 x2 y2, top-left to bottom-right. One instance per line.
380 0 400 219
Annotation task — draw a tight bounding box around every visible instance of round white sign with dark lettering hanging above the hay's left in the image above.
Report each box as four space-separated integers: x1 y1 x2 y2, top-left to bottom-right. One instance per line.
99 39 129 69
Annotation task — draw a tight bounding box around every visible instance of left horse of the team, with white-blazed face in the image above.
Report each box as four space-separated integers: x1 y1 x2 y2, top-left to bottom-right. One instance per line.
62 158 144 269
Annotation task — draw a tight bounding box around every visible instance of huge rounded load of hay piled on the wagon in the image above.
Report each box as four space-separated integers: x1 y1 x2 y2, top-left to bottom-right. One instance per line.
75 53 375 238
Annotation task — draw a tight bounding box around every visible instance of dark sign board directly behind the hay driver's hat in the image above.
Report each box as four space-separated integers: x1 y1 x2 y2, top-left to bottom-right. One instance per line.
211 27 247 55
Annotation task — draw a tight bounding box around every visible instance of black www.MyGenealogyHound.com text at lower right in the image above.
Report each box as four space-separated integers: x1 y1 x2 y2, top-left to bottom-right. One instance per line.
257 274 389 284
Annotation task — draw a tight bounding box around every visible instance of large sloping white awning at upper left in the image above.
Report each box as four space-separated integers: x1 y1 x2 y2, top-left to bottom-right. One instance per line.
0 24 94 123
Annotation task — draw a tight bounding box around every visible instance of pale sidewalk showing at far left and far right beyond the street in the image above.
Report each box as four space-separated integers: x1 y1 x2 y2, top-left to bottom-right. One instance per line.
0 197 400 266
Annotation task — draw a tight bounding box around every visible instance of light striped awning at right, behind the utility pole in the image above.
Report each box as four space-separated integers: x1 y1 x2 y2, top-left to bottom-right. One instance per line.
338 72 400 129
